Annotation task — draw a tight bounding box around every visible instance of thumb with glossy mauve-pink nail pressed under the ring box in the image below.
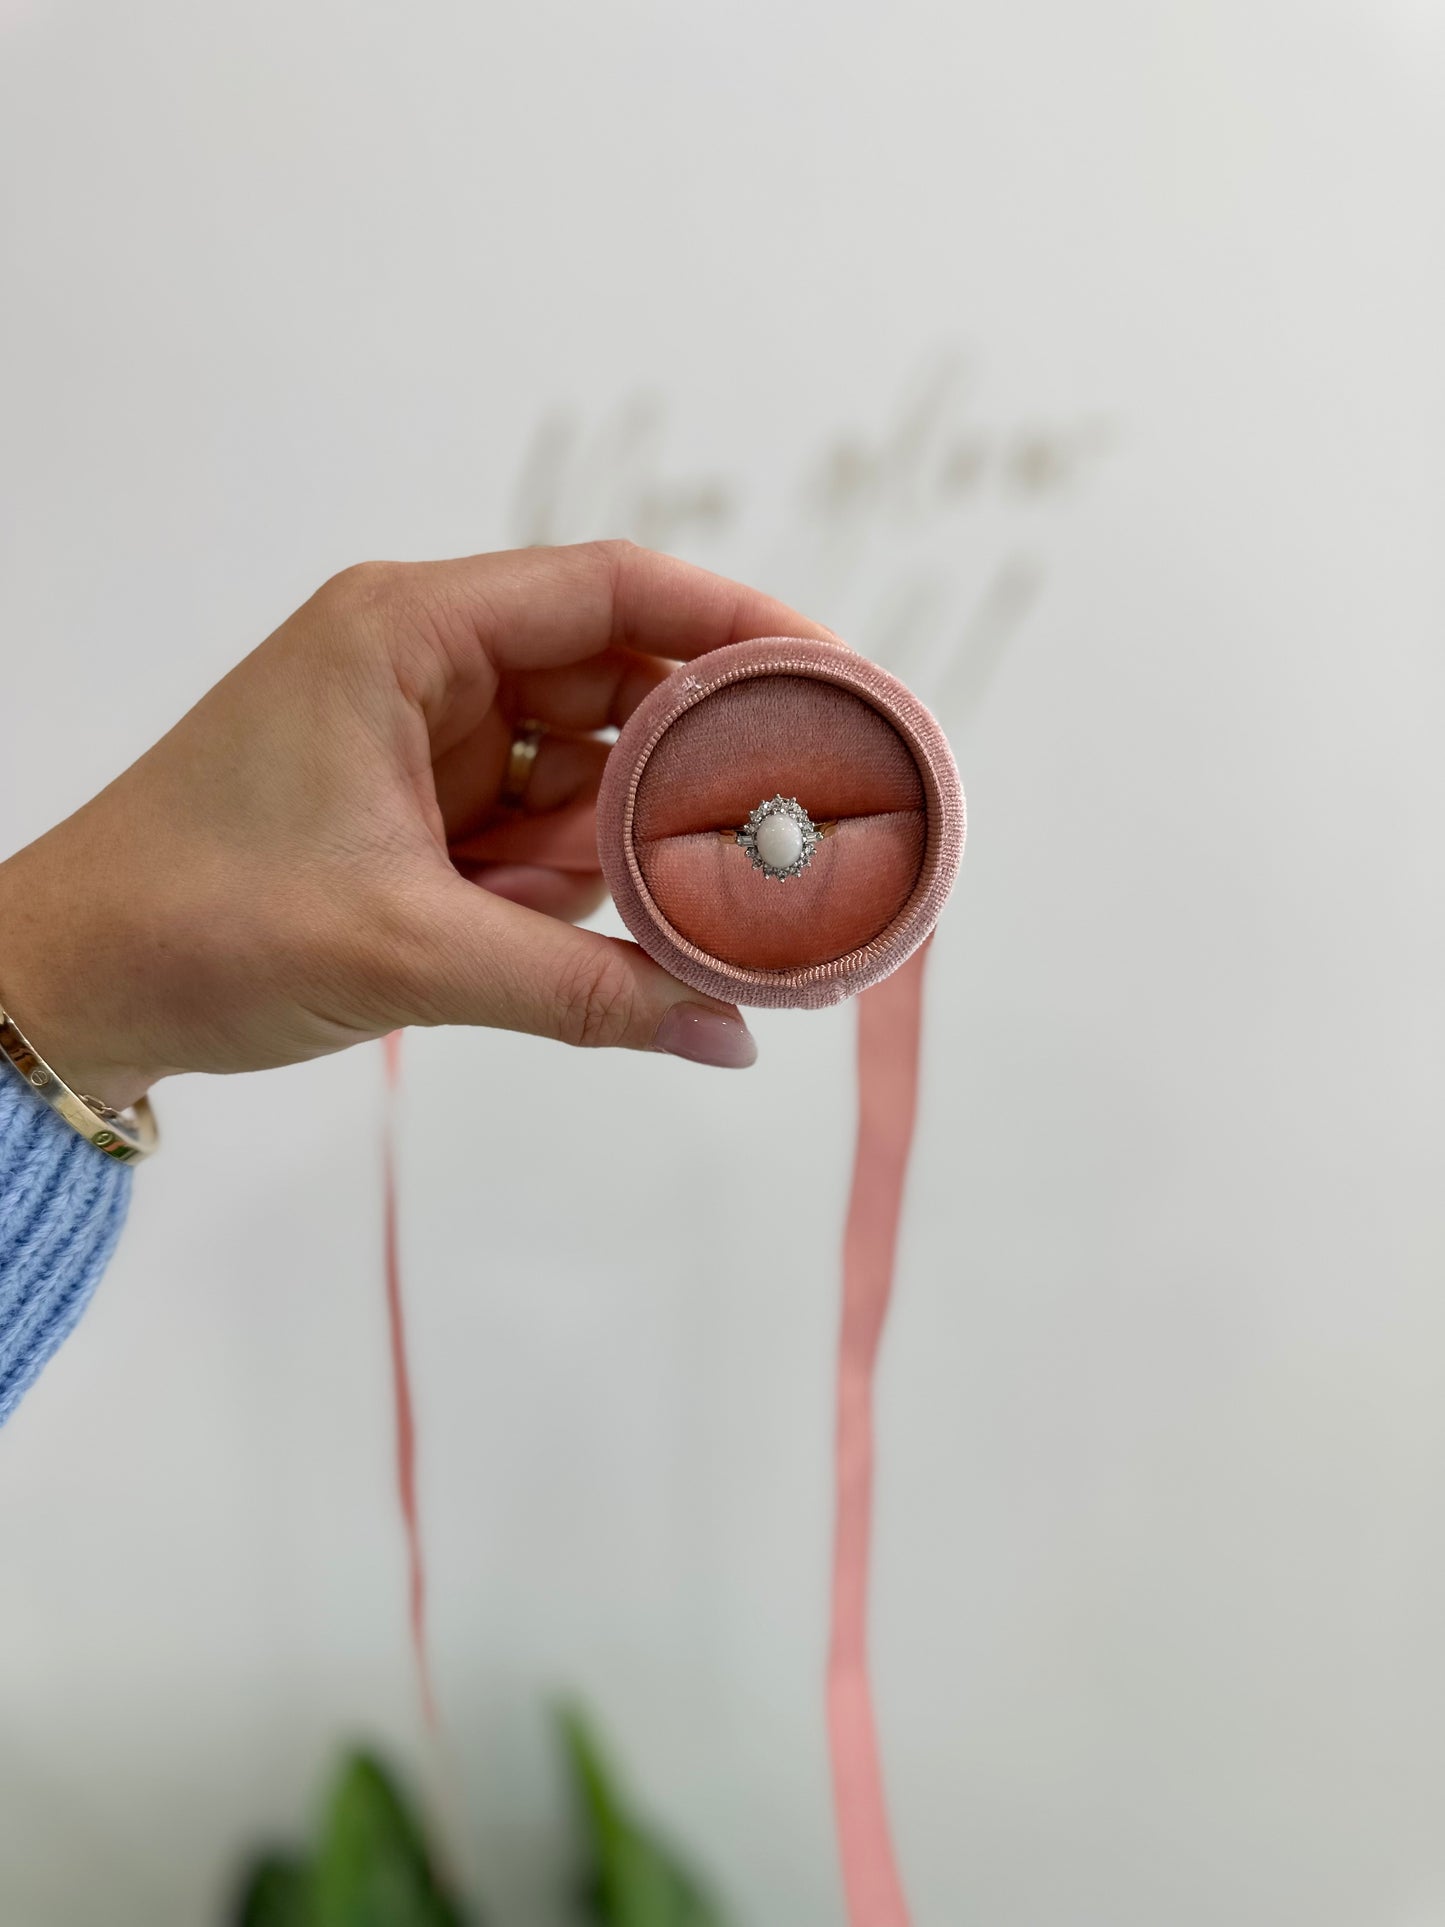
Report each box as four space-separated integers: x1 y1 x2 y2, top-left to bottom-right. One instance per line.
391 871 757 1069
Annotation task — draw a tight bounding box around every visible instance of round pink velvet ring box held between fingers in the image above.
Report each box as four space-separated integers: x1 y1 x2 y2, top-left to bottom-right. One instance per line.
597 636 963 1008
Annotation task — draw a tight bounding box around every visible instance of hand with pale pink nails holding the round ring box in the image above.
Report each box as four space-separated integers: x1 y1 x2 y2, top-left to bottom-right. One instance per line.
0 541 834 1108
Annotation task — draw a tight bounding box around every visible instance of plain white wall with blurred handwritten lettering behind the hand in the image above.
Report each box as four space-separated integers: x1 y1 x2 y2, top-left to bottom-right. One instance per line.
0 0 1445 1927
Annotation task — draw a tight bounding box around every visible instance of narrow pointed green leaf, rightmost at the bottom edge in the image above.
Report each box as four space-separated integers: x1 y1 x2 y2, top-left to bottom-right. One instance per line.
561 1707 723 1927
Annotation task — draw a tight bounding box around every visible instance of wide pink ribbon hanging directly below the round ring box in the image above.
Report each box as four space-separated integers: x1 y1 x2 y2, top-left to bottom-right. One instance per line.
828 944 927 1927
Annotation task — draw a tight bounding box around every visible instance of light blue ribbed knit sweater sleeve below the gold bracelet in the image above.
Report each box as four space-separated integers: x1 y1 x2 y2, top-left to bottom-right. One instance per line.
0 1058 133 1424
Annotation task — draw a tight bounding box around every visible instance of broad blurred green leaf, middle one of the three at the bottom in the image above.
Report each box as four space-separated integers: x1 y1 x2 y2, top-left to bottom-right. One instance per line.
314 1754 462 1927
